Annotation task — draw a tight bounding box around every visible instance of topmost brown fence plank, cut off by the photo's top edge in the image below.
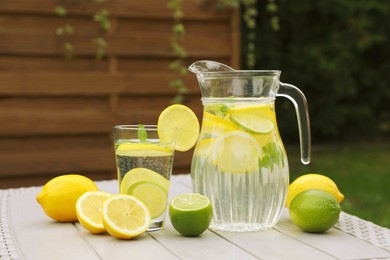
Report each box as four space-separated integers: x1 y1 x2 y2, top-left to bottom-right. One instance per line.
0 0 231 20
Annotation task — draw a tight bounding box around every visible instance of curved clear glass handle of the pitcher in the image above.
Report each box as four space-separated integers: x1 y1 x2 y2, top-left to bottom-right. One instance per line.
277 82 311 164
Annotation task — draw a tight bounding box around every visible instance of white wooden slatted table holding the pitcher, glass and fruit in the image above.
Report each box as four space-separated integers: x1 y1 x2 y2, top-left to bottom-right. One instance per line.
0 175 390 260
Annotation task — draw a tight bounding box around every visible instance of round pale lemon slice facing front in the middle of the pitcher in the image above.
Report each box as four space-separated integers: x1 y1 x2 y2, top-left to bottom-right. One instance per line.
211 131 261 174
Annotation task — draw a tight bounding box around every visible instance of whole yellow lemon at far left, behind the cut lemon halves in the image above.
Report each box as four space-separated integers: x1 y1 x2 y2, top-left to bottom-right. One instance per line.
36 174 98 222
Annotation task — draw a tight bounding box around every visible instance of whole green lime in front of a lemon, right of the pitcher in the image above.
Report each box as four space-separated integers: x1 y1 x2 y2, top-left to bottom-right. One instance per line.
289 190 341 233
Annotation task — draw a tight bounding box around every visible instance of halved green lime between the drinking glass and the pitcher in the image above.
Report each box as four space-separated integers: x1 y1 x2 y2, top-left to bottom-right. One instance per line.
169 193 213 237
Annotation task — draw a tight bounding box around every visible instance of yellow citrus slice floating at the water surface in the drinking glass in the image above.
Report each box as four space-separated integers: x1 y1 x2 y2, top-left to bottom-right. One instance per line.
115 143 172 156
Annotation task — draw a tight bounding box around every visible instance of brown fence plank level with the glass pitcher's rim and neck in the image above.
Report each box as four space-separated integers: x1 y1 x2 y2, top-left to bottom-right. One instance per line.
0 70 199 96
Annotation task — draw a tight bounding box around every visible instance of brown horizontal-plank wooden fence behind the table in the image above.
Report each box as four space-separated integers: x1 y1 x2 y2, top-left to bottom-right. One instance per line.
0 0 239 188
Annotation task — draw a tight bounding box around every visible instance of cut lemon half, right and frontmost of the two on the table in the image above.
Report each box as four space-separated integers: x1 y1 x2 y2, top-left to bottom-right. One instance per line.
102 194 151 239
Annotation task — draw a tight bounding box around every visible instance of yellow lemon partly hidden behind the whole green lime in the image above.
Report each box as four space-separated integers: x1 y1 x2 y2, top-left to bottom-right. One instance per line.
286 173 344 207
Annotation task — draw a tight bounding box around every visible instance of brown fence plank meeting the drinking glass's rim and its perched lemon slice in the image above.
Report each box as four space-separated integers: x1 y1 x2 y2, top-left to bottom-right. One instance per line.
0 96 202 136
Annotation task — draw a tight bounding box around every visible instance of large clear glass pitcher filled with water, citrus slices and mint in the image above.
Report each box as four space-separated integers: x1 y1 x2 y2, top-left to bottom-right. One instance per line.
189 61 311 232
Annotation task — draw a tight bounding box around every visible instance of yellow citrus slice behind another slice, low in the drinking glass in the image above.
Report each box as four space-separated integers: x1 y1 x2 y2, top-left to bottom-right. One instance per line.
120 168 169 194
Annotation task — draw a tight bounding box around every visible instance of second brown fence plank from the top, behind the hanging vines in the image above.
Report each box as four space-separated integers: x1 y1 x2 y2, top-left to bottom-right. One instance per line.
0 15 231 57
